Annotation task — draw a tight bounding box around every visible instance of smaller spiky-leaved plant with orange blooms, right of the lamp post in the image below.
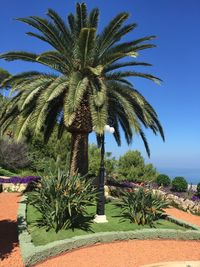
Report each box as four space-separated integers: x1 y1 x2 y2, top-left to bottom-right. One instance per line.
120 188 169 226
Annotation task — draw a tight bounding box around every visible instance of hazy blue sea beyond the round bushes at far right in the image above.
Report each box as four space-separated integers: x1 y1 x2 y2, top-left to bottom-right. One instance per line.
157 168 200 185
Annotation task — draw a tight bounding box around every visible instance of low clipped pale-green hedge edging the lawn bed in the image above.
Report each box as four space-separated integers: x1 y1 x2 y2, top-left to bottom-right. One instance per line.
17 196 200 267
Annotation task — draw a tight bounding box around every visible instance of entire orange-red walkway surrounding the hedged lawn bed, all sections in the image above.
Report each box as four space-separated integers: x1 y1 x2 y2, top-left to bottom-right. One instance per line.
0 193 200 267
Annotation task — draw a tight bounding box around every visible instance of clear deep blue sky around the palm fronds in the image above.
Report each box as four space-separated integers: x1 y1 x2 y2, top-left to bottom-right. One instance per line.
0 0 200 172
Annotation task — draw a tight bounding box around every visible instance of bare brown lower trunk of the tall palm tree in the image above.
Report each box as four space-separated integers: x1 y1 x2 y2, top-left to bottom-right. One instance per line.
70 132 89 176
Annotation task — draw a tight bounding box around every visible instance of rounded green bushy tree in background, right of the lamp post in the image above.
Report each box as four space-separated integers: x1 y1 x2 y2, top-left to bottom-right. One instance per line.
117 151 157 182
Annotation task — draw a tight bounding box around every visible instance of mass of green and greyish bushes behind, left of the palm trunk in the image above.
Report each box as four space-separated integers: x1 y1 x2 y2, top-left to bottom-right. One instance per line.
0 125 71 176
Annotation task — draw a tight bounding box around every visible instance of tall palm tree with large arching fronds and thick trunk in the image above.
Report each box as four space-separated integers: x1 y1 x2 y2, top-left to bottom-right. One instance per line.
0 3 164 177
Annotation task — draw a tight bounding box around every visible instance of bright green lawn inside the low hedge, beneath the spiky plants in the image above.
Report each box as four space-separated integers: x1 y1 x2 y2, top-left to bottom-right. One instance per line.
27 203 186 246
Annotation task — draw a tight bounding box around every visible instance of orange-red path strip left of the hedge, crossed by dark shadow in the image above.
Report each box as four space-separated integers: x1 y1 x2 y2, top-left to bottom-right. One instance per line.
0 193 23 267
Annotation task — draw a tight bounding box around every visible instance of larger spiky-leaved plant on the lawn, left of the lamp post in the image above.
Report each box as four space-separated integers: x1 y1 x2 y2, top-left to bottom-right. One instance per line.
27 172 96 232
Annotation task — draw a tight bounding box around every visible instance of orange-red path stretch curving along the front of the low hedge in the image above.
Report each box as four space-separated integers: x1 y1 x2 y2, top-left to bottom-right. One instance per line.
35 240 200 267
